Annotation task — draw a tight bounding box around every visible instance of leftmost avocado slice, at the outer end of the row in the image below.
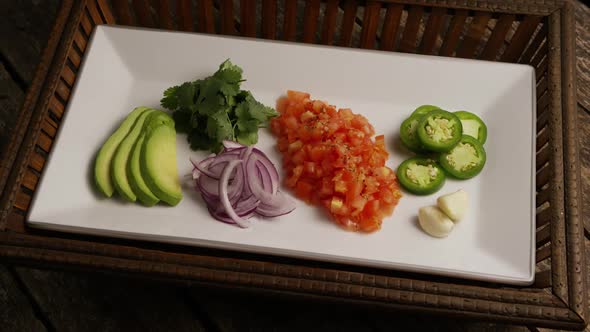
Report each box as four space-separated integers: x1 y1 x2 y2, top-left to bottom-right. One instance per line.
94 107 147 197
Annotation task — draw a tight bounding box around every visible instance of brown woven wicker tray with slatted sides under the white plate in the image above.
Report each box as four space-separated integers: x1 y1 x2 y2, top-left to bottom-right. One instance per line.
0 0 587 329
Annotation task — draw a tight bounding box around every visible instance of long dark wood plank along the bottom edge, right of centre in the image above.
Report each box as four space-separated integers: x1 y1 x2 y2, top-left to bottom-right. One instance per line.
190 287 528 332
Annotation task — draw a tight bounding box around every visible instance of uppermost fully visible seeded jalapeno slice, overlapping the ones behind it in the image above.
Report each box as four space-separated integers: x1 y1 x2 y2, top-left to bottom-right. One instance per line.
417 110 463 152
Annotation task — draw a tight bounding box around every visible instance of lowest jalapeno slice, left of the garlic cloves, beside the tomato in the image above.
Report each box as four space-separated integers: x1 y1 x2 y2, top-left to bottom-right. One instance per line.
396 157 446 195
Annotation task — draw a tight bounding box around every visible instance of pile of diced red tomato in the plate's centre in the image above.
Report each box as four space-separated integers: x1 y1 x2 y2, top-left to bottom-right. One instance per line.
270 91 401 232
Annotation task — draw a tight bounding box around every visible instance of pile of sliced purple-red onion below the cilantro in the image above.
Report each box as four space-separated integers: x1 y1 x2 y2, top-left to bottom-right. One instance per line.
191 141 295 228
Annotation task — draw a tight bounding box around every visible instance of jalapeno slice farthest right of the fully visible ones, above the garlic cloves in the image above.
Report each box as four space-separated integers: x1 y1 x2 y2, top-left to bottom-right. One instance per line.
439 135 486 180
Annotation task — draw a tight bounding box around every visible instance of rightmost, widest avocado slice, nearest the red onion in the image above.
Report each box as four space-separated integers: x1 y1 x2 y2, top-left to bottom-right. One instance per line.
140 112 182 206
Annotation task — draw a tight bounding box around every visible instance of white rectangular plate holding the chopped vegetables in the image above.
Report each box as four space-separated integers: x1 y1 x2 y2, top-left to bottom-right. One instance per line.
29 26 535 285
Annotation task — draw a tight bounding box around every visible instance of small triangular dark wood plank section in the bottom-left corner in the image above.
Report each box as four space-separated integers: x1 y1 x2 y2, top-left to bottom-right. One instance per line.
0 265 47 332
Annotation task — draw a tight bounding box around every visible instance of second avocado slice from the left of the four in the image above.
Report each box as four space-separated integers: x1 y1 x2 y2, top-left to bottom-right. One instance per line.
111 109 154 202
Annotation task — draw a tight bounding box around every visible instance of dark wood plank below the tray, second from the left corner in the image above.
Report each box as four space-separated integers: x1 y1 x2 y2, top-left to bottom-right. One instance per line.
16 268 205 332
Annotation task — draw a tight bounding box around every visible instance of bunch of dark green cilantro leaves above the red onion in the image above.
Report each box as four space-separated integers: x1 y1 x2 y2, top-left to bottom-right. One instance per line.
160 59 278 152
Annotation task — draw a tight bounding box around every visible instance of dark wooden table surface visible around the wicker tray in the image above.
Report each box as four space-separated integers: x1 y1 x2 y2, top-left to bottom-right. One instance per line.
0 0 590 332
